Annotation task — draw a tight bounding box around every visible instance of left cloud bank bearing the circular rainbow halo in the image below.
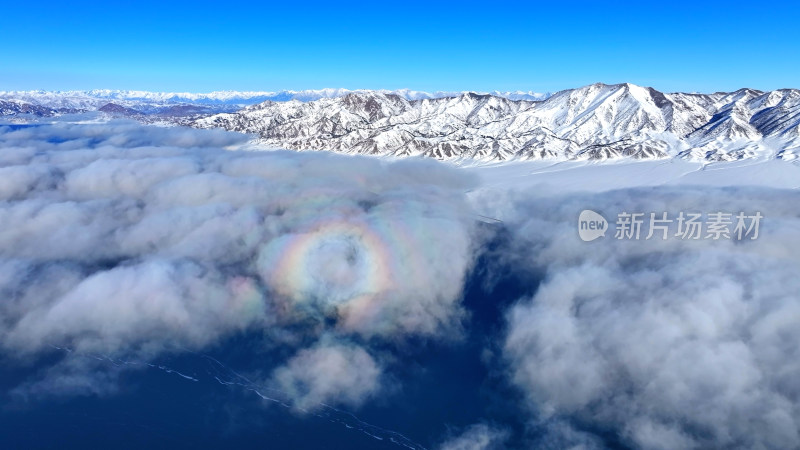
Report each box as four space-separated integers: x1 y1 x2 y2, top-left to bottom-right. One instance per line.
0 123 473 406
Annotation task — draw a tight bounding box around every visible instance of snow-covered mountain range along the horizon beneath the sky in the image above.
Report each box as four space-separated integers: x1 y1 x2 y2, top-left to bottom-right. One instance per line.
0 83 800 161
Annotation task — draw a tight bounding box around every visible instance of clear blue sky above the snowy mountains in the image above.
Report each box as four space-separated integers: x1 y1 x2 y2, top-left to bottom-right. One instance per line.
0 0 800 92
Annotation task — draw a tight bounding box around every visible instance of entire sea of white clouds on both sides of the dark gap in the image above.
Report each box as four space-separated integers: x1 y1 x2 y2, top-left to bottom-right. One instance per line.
0 122 800 449
